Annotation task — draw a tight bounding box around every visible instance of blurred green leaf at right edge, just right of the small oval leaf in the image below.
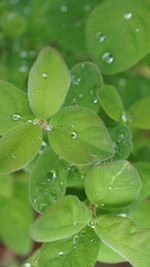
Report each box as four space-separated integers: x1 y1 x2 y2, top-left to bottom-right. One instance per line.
129 96 150 129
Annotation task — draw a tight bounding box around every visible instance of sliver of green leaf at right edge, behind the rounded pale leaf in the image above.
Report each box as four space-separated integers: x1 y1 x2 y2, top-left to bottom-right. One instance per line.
134 161 150 199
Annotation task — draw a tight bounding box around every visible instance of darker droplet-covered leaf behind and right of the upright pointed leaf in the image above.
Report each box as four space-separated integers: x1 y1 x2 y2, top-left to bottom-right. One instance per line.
65 62 103 112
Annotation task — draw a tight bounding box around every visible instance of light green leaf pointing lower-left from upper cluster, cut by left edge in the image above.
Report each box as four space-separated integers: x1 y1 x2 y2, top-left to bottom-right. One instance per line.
0 123 42 175
